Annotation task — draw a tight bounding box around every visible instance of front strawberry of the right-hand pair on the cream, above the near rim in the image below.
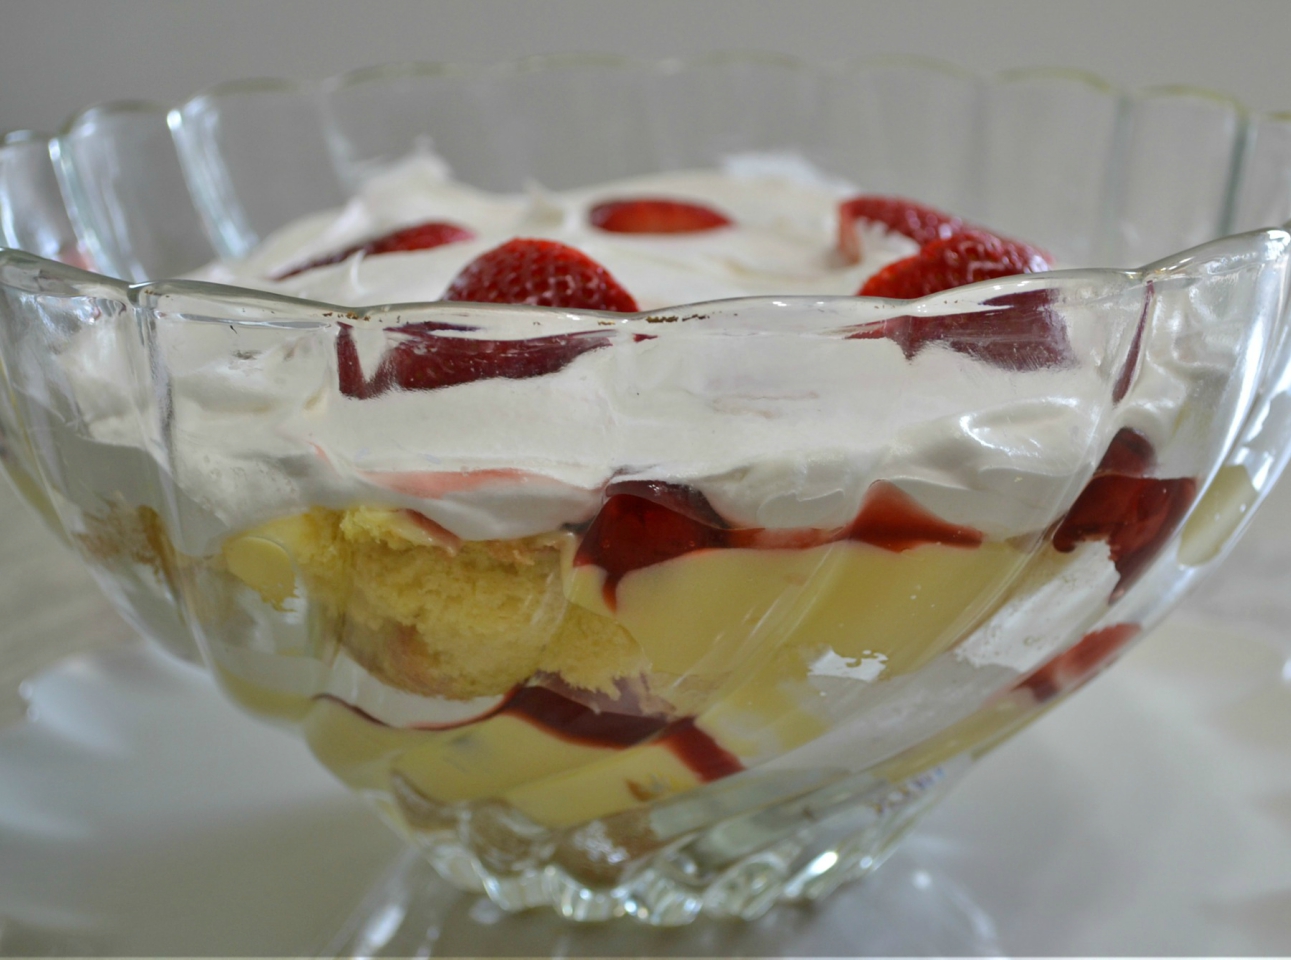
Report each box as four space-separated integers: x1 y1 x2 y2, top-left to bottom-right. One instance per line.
856 230 1050 299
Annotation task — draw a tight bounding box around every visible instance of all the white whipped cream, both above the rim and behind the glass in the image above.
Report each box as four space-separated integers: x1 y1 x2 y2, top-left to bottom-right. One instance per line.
52 151 1239 554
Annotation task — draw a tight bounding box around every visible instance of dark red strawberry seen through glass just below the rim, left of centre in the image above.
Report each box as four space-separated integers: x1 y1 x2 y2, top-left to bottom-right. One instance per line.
336 323 609 400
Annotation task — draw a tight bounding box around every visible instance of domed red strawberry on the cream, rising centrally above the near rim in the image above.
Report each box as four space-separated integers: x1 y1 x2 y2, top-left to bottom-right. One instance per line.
444 237 636 314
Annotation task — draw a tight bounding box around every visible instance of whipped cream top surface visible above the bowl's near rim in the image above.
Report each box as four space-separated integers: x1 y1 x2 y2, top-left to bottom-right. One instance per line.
195 155 918 310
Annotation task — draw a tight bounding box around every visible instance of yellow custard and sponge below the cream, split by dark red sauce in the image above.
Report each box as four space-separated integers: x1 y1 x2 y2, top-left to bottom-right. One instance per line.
217 507 1032 826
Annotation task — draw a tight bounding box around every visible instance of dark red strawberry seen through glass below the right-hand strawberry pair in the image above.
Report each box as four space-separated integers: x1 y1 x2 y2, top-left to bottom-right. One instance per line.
852 290 1072 370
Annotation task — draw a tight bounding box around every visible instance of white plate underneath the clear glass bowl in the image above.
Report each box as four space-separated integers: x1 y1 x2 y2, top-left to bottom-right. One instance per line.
0 603 1291 956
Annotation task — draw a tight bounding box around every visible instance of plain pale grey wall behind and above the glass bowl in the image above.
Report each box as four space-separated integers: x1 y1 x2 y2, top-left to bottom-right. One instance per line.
0 0 1291 132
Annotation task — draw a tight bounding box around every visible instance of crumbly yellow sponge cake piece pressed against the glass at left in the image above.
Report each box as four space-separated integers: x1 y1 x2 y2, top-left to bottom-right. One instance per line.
223 507 644 699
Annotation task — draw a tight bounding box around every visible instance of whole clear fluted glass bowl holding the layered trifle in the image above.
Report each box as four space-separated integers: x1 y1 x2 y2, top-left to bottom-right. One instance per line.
0 55 1291 925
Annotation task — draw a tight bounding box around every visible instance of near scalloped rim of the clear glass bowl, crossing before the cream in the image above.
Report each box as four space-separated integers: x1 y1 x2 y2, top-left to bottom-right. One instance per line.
0 223 1291 339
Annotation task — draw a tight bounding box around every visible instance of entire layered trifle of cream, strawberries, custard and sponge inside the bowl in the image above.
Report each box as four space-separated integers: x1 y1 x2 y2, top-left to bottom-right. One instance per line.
50 157 1238 856
